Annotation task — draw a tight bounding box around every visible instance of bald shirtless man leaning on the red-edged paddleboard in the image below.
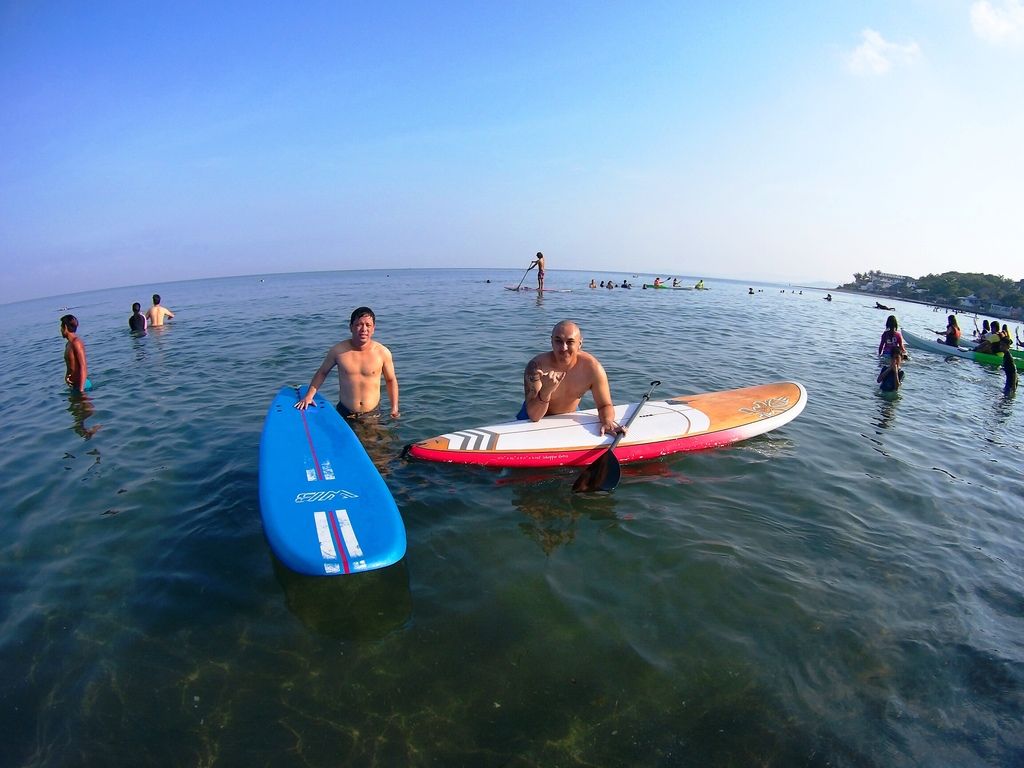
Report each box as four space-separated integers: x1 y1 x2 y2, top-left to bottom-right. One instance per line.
516 321 626 434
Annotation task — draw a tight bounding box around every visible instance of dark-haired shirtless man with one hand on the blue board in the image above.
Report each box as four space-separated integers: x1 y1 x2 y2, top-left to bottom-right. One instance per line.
295 306 399 419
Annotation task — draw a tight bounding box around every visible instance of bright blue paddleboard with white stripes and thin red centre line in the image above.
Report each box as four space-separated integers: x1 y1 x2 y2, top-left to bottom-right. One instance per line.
259 387 406 575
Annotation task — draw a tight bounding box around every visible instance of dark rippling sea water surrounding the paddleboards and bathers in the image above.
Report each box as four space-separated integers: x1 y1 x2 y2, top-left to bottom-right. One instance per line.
0 269 1024 767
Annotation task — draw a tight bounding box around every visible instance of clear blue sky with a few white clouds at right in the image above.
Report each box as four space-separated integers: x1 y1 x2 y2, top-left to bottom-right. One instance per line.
0 0 1024 303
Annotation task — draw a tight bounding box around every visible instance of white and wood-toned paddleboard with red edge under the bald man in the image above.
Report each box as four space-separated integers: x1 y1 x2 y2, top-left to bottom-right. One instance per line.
408 381 807 467
